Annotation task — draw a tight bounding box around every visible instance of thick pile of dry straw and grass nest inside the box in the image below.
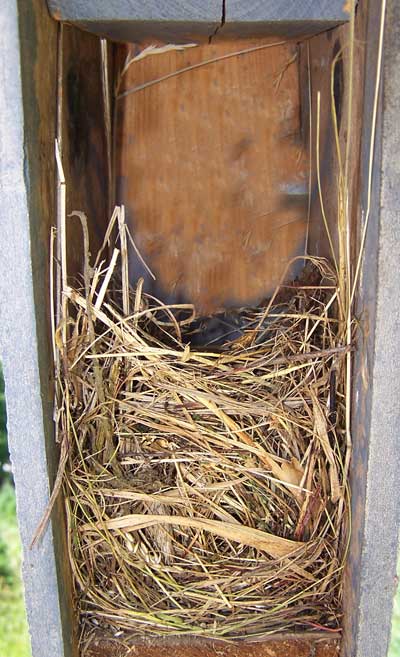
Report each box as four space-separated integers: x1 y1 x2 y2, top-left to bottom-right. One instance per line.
54 208 348 638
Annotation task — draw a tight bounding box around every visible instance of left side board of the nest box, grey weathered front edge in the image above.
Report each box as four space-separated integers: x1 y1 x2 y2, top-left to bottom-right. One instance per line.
9 0 78 657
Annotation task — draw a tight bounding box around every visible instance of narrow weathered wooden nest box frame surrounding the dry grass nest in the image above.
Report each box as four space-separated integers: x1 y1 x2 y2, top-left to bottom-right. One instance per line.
0 0 400 657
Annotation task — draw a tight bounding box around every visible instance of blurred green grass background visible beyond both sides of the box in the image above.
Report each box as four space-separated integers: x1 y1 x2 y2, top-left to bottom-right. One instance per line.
0 365 400 657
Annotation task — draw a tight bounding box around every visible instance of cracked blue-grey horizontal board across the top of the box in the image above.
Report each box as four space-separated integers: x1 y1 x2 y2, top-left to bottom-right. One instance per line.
48 0 349 42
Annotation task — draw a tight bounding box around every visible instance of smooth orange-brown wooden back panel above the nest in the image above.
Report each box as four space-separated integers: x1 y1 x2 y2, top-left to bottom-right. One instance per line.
116 40 308 312
